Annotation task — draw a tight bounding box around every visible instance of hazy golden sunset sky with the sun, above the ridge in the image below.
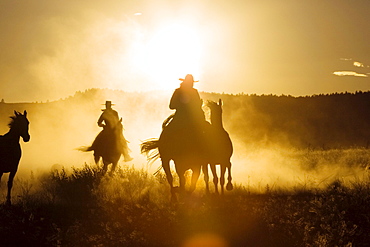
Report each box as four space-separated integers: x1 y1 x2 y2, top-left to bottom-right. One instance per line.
0 0 370 102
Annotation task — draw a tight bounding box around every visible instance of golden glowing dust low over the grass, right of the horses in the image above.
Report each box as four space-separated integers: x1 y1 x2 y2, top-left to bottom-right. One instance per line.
233 146 370 192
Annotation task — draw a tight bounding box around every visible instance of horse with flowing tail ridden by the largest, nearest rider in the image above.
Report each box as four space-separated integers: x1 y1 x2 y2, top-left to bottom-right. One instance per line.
141 114 207 201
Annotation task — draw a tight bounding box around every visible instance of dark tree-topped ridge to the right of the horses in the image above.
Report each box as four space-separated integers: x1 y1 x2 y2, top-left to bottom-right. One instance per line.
205 92 370 149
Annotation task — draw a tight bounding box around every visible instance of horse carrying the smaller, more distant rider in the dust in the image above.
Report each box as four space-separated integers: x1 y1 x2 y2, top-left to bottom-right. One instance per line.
78 118 126 174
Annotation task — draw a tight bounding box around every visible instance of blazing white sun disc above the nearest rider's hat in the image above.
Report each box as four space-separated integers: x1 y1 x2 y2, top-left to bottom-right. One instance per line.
133 23 203 90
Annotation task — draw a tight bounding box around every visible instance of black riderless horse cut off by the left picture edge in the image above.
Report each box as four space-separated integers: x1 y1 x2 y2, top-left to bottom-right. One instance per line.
0 111 30 205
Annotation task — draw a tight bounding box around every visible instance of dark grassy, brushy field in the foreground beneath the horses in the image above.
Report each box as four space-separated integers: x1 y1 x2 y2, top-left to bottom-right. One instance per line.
0 150 370 246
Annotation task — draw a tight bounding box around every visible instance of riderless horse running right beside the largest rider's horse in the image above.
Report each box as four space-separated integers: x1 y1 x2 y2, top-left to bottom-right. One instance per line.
202 99 233 194
